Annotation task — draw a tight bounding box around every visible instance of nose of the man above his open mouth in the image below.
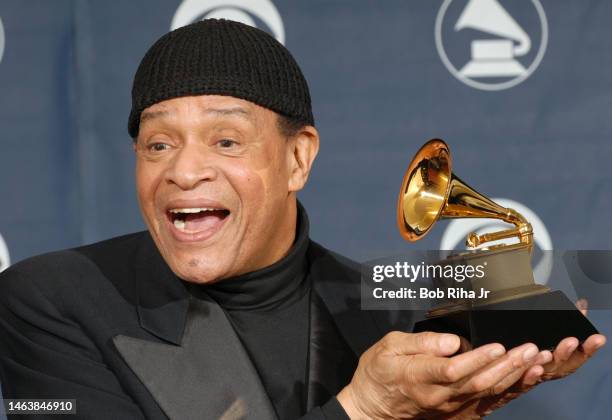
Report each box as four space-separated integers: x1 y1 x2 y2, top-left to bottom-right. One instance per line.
165 142 217 190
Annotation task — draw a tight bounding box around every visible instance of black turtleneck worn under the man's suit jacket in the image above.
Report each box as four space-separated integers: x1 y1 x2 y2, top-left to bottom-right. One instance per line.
189 205 311 419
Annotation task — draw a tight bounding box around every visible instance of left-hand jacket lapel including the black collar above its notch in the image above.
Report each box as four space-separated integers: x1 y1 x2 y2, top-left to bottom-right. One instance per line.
113 234 276 420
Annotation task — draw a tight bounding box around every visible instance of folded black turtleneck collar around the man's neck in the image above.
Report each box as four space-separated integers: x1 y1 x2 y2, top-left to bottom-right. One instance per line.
187 202 309 311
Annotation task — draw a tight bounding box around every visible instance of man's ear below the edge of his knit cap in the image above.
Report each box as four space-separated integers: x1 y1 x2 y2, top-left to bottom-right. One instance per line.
288 125 319 192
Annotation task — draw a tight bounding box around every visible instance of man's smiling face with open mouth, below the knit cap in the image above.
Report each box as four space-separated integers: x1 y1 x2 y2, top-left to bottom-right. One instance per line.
135 95 318 283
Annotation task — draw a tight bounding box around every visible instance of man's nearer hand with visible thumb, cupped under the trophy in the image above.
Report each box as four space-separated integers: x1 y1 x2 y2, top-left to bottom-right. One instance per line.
337 332 538 419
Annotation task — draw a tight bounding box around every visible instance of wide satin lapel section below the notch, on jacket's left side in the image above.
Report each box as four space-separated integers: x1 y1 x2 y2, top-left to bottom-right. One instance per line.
114 299 276 420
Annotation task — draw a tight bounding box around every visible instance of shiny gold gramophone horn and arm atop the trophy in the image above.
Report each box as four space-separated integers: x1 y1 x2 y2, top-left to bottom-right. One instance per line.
397 139 533 248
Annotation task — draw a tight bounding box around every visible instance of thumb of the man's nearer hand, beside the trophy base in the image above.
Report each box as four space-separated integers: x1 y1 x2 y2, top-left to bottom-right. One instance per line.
382 331 460 356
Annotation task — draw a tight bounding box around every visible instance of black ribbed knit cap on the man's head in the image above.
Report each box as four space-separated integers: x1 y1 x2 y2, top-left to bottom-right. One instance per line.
128 19 314 138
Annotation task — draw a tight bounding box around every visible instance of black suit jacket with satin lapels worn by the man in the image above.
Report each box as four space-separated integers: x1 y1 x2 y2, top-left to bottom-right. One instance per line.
0 232 402 420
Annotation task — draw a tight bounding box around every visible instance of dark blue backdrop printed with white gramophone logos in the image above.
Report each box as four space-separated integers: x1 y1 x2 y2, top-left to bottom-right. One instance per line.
0 0 612 419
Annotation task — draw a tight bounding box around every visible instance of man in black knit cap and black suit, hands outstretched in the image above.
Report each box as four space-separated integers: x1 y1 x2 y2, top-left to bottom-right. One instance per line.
0 20 605 420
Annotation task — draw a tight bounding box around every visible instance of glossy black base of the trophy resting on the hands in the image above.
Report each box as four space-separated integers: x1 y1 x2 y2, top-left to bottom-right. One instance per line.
413 291 598 350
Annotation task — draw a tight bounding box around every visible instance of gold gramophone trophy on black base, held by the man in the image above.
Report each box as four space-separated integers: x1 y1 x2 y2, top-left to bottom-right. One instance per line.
397 139 597 349
